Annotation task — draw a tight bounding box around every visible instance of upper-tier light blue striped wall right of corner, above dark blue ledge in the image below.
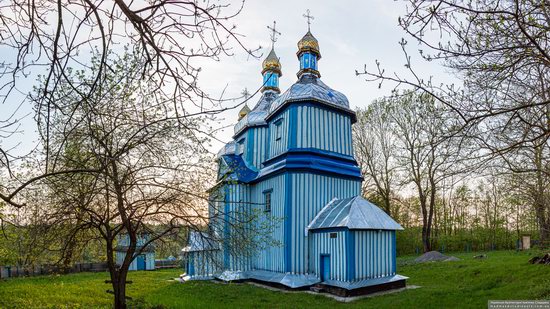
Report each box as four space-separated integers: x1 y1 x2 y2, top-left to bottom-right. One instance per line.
293 104 353 156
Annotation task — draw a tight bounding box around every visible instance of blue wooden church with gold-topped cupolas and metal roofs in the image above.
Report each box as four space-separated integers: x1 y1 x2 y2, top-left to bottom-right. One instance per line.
182 19 406 296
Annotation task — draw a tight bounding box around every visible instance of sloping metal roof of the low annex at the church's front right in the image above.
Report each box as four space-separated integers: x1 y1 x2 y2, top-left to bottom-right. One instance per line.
307 196 403 230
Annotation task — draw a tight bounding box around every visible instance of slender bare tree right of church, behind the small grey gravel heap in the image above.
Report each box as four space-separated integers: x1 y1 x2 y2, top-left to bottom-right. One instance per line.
392 92 468 251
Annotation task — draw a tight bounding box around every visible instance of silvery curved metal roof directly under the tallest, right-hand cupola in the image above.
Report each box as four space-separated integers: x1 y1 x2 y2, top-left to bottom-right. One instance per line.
269 74 350 114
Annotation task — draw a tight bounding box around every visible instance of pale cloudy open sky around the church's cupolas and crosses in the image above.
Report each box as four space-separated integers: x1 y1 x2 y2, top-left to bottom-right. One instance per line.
0 0 453 154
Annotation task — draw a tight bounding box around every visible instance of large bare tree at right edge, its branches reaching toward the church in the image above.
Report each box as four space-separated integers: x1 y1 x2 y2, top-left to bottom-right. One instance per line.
357 0 550 243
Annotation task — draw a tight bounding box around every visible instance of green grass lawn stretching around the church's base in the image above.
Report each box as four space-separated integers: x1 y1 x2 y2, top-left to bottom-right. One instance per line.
0 251 550 308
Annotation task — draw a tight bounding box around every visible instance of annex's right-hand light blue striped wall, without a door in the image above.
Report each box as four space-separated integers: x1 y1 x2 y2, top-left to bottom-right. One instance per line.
353 230 396 280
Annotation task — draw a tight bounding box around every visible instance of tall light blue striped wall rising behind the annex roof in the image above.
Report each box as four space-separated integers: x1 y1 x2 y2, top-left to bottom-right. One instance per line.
285 172 361 273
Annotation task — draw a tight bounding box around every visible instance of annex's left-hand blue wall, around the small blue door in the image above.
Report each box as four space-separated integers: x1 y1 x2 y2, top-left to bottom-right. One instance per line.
309 231 348 281
